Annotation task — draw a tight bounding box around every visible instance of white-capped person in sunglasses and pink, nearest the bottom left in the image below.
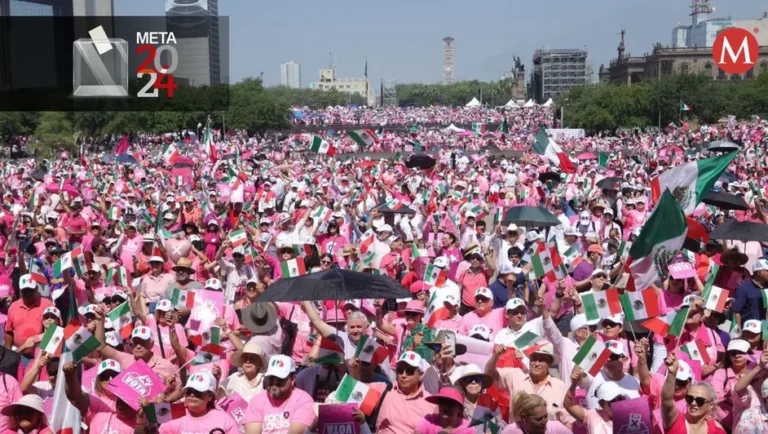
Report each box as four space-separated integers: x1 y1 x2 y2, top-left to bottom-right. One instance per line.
158 371 240 434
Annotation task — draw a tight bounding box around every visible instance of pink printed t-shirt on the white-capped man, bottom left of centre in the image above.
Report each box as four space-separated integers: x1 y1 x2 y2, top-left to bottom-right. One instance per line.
248 389 315 434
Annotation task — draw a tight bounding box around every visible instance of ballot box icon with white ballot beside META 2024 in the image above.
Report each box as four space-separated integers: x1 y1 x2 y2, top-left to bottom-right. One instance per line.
72 26 129 98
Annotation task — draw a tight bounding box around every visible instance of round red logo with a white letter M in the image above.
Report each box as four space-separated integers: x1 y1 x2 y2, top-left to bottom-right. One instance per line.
712 27 760 75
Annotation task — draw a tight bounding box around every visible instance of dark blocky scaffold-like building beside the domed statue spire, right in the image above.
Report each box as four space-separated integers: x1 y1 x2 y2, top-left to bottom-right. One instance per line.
531 49 589 103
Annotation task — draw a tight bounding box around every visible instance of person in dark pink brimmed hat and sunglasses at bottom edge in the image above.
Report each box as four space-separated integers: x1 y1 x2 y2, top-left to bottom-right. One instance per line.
415 386 476 434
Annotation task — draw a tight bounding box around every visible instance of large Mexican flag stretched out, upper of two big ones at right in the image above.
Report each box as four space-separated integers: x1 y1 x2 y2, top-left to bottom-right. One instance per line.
646 152 739 214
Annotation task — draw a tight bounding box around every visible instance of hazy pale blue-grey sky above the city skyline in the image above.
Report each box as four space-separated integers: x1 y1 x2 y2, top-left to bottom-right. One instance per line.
114 0 768 87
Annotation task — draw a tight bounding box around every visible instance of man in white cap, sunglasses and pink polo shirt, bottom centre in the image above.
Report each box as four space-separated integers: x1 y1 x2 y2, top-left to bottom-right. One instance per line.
378 351 437 434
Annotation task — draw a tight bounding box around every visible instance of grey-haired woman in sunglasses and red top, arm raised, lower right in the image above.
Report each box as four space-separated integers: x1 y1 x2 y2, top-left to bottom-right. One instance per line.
661 354 725 434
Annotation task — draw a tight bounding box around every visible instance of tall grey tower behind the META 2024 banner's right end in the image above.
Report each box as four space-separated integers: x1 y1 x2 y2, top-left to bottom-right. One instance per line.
165 0 222 86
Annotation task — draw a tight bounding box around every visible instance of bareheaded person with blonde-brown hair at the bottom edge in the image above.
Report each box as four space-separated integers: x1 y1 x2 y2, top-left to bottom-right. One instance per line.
502 392 572 434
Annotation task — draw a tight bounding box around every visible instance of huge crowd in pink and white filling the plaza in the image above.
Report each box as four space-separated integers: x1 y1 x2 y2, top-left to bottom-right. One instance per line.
0 112 768 434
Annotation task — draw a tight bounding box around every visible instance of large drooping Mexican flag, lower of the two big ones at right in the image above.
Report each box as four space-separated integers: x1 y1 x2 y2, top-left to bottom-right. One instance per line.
629 191 688 289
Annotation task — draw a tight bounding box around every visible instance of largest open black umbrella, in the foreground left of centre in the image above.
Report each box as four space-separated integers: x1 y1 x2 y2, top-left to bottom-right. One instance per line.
256 268 411 302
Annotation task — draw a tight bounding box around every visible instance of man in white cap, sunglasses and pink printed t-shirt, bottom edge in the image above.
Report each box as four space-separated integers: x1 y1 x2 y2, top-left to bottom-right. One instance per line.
245 355 315 434
